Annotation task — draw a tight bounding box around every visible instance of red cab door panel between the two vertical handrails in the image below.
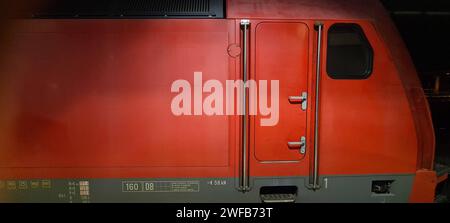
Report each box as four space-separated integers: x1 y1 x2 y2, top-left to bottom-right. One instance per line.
252 22 309 162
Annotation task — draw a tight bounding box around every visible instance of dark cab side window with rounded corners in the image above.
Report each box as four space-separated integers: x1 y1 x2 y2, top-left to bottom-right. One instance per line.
327 24 373 79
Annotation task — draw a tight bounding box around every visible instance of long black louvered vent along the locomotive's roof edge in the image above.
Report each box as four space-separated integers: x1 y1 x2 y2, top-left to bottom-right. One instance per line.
32 0 225 19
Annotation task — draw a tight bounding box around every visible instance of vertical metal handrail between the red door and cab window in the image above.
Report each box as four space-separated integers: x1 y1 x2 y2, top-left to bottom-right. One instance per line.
312 22 323 190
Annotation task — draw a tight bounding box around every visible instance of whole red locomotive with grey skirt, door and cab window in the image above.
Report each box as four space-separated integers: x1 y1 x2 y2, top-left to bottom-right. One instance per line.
0 0 439 202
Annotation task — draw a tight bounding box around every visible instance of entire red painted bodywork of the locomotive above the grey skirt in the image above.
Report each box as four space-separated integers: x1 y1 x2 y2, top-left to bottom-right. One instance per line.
0 0 434 191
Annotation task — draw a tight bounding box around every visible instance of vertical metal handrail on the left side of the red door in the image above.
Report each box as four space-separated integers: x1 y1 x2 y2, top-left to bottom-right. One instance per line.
240 19 250 192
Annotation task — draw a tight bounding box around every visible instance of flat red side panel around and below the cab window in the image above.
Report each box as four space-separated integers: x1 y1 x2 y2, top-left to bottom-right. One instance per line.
319 21 418 174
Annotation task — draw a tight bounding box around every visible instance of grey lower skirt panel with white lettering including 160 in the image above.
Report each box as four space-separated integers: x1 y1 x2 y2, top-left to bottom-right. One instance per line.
0 175 414 203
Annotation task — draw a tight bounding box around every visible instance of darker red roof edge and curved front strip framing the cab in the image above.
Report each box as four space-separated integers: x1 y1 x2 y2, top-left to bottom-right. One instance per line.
227 0 435 169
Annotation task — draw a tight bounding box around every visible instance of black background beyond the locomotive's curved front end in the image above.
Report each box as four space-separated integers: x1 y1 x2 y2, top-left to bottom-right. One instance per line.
382 0 450 201
